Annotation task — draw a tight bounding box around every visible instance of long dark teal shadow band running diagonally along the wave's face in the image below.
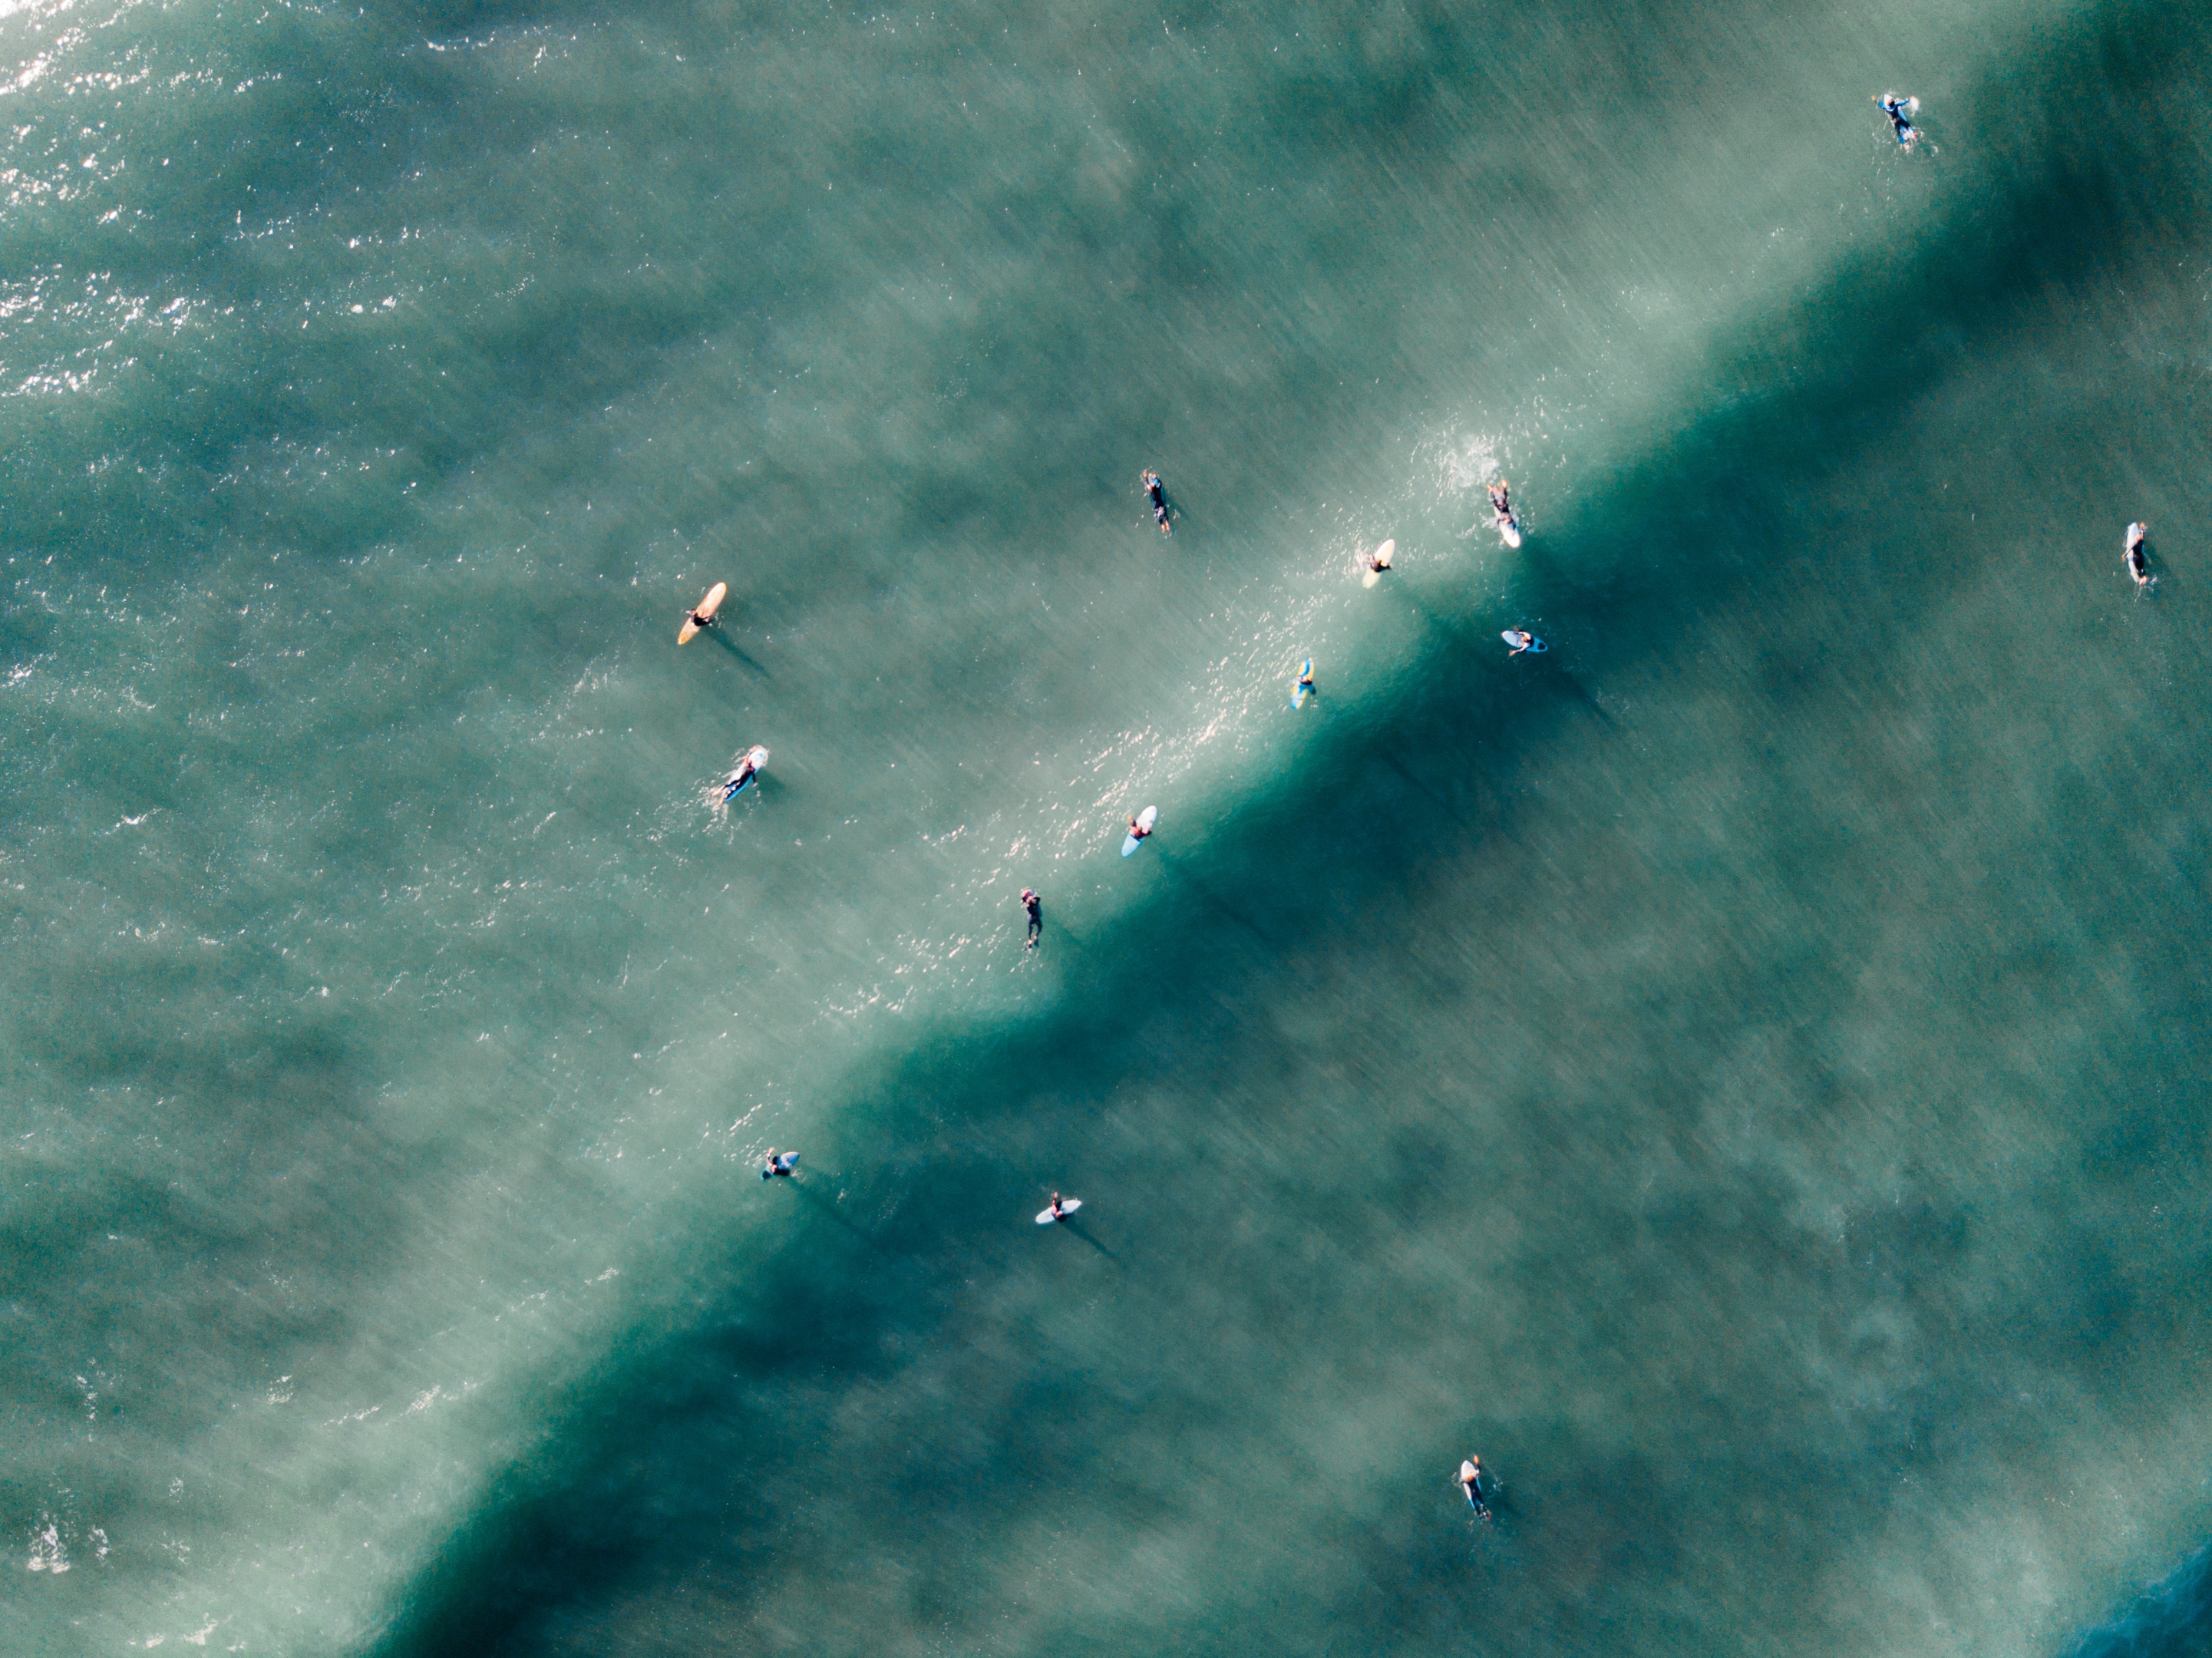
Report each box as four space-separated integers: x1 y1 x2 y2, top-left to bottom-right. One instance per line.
374 7 2212 1658
